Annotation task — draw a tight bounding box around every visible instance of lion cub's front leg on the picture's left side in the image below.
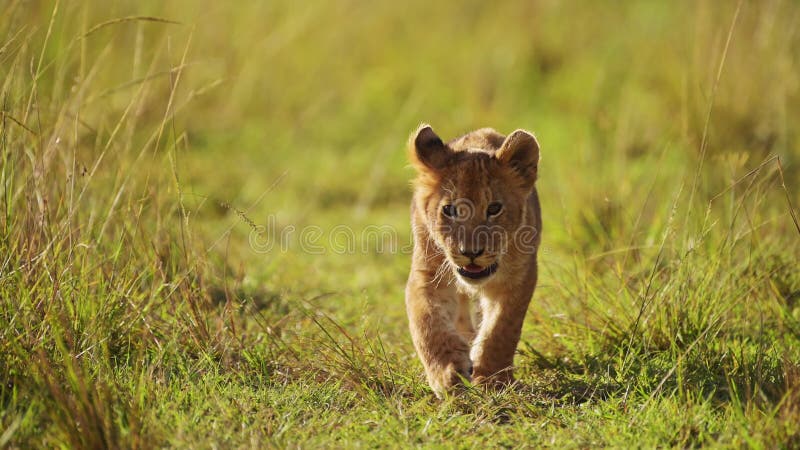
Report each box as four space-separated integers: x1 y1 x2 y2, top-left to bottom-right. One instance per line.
406 277 472 397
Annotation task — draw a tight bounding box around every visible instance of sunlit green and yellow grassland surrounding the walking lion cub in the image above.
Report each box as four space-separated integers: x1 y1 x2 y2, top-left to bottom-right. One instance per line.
0 0 800 448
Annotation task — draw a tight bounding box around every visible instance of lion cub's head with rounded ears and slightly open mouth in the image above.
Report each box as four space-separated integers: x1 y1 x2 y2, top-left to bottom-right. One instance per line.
409 125 539 285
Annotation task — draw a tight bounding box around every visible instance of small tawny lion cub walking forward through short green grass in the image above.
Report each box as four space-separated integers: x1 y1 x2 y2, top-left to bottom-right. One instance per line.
406 124 542 396
